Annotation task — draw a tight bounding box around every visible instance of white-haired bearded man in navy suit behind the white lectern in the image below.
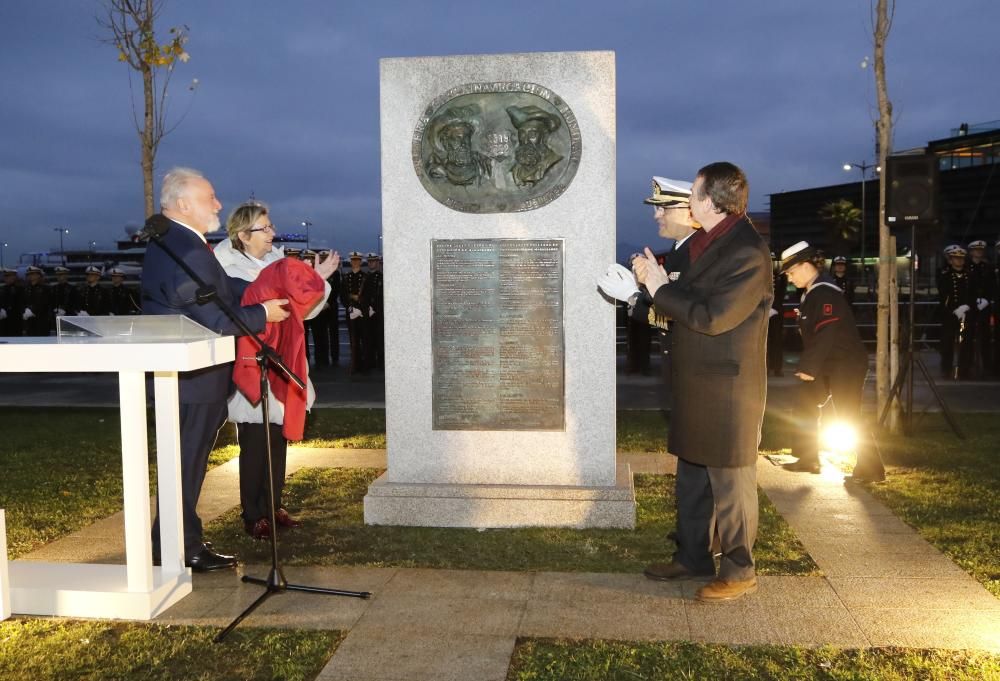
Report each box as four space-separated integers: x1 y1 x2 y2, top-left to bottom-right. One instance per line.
142 168 289 572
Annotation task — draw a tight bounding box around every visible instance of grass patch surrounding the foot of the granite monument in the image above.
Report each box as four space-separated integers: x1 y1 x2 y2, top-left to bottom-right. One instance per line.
205 468 818 575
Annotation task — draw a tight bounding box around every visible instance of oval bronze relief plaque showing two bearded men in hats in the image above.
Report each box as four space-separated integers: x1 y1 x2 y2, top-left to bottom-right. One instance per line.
413 81 582 213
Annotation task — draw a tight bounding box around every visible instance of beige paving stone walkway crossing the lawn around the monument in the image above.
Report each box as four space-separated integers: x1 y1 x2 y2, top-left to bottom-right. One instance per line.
15 448 1000 681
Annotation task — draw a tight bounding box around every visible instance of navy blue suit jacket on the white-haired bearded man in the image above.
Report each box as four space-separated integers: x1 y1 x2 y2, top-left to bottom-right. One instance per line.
142 215 267 404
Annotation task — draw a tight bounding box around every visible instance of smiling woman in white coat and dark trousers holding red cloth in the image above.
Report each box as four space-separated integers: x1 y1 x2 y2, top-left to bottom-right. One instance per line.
215 201 340 539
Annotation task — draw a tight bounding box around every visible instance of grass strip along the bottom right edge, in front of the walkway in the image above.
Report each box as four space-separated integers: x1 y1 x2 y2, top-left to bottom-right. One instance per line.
507 639 1000 681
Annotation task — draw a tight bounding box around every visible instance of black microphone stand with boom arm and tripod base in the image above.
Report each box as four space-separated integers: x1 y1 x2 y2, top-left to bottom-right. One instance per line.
136 215 372 643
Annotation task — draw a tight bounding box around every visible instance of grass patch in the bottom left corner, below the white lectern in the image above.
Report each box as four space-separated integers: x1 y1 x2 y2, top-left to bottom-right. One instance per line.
0 619 344 681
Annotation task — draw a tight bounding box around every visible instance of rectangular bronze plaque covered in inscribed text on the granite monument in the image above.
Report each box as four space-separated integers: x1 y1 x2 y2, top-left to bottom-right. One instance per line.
431 239 566 430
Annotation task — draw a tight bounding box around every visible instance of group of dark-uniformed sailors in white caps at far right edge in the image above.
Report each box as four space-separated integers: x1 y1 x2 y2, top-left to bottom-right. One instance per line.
937 240 1000 379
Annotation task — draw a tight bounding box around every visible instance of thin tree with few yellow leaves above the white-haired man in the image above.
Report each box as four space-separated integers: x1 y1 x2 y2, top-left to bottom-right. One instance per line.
97 0 191 216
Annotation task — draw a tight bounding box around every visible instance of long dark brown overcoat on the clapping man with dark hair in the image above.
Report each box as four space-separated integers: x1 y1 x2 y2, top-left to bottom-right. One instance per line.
653 218 774 468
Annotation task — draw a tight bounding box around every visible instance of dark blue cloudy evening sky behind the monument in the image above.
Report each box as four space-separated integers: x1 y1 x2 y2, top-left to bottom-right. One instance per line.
0 0 1000 264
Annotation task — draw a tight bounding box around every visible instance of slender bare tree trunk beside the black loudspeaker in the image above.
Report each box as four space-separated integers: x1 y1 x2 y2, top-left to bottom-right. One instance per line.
873 0 896 424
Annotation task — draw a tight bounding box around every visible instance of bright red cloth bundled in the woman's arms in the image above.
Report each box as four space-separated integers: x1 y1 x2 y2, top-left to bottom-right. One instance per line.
233 258 325 440
